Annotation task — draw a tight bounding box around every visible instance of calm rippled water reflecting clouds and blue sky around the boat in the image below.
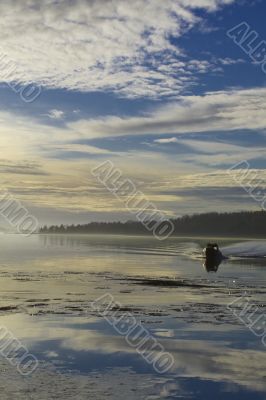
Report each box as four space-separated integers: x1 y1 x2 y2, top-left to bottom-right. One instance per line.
0 235 266 400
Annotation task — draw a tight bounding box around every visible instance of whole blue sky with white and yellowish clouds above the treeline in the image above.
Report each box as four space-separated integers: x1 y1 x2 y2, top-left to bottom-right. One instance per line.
0 0 266 224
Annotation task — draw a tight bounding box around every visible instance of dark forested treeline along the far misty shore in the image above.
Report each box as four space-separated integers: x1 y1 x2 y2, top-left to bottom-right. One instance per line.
39 211 266 236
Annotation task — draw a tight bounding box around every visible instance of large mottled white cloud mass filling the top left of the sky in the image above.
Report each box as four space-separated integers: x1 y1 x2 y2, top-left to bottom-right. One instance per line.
0 0 234 97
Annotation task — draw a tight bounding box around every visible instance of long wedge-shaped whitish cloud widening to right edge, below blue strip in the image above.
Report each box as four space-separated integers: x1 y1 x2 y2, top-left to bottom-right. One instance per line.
68 88 266 138
